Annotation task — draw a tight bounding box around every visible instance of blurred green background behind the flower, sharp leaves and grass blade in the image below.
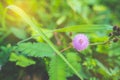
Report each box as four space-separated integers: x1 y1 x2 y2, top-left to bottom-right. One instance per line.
0 0 120 80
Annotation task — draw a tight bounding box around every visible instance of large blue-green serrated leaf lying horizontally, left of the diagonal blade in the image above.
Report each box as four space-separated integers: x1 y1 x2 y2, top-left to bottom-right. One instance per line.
16 43 54 57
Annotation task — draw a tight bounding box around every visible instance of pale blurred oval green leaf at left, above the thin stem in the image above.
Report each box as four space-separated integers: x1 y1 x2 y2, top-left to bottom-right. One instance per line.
11 27 26 39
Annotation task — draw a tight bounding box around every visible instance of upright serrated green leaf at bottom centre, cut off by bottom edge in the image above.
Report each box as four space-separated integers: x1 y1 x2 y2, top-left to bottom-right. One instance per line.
49 55 66 80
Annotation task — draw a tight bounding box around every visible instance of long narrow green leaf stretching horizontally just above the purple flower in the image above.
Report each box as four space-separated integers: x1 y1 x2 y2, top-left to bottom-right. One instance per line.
55 25 112 32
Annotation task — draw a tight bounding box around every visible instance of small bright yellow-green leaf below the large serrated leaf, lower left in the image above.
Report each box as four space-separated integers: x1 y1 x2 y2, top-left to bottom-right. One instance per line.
9 53 35 67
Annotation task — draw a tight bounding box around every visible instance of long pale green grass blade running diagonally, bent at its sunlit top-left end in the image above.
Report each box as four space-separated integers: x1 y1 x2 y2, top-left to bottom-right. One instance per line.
7 5 83 80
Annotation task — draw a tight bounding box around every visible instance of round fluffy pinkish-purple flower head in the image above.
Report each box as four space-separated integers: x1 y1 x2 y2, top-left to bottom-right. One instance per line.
72 34 89 51
